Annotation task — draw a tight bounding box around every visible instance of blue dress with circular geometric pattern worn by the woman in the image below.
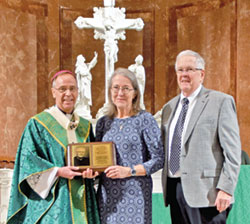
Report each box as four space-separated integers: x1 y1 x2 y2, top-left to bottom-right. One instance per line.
96 111 164 224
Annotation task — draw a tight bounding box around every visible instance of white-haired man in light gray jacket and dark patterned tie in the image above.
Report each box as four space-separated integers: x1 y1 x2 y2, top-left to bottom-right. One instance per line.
161 50 241 224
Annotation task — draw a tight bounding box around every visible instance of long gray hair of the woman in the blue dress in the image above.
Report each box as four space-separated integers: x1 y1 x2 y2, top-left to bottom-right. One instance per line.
105 68 142 118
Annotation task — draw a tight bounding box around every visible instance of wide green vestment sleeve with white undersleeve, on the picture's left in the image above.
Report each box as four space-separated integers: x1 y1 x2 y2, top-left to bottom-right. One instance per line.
14 119 64 198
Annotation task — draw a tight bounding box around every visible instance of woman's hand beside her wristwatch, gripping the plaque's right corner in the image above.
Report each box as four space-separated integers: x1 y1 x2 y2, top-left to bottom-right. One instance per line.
104 166 131 179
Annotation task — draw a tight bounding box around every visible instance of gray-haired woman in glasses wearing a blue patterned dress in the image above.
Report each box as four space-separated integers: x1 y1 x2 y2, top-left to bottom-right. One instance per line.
96 68 164 224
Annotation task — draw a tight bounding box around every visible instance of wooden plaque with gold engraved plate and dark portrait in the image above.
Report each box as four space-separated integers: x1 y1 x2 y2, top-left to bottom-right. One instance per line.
66 142 116 171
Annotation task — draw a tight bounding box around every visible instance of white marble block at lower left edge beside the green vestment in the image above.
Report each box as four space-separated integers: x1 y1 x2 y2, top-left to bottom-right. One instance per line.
0 169 13 224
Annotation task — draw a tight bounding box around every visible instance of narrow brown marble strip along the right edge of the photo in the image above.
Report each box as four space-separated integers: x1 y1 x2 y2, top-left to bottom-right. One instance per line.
235 0 250 153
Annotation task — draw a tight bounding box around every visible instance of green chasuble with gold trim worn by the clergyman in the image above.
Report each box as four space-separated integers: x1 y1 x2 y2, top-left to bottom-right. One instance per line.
7 112 100 224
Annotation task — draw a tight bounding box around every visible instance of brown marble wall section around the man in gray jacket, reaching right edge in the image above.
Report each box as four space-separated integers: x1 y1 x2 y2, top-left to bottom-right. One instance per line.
166 0 250 155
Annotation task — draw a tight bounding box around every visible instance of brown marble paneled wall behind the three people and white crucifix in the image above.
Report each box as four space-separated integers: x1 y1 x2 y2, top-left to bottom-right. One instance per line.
0 0 250 223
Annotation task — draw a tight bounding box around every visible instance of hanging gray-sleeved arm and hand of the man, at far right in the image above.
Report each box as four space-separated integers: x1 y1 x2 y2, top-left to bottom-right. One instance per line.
215 96 241 212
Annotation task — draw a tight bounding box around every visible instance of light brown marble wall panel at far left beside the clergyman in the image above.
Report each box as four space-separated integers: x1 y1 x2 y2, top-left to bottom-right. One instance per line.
0 4 38 166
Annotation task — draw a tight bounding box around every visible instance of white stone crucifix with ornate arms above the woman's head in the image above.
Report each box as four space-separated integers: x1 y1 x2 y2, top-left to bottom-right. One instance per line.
75 0 144 104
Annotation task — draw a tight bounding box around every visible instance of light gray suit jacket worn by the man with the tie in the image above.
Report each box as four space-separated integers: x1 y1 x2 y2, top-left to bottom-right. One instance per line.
161 87 241 207
